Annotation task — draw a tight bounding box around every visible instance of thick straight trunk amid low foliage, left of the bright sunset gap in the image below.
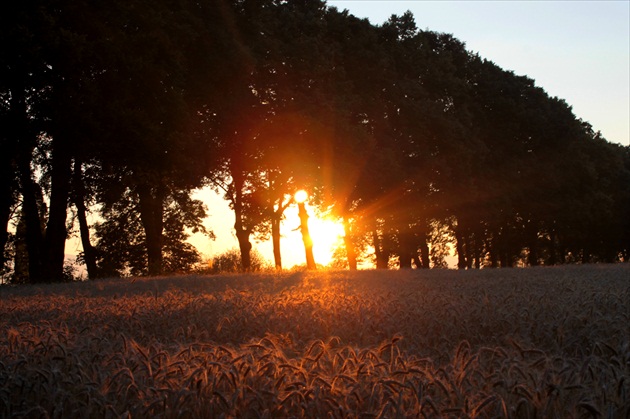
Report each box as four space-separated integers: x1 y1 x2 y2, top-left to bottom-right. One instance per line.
138 180 165 276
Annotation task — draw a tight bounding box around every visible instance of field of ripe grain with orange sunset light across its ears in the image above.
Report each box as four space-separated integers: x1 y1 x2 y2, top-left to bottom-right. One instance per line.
0 264 630 418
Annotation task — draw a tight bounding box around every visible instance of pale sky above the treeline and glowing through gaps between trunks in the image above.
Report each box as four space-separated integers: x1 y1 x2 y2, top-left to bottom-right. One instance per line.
191 0 630 267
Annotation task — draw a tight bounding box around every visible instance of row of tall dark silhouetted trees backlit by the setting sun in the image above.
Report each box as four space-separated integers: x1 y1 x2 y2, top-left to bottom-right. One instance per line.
0 0 630 283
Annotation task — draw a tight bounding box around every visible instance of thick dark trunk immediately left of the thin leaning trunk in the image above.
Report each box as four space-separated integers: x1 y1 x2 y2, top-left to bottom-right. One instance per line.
44 142 72 282
